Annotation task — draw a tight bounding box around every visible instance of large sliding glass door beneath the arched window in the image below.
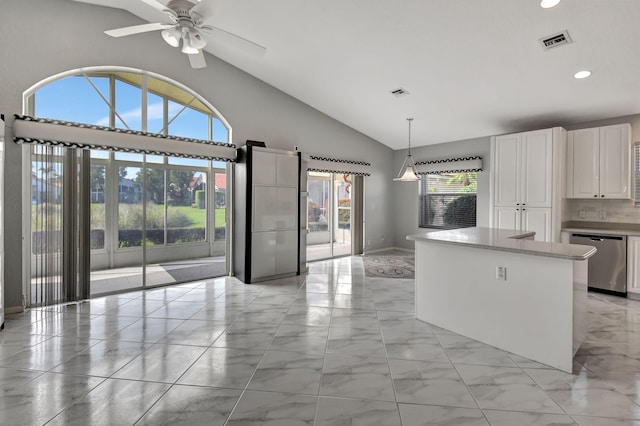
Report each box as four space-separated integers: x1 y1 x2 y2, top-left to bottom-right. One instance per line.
28 145 227 306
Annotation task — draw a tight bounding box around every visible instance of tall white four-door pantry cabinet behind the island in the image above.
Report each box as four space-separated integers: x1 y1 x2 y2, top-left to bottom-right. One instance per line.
491 128 566 241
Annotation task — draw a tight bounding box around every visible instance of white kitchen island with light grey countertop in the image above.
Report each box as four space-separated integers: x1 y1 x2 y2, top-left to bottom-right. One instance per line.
407 228 596 372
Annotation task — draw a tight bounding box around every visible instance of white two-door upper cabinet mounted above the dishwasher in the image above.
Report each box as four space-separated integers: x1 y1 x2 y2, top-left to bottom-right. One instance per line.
567 124 632 199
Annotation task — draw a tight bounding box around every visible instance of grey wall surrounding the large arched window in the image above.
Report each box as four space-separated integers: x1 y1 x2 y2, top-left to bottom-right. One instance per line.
0 0 394 308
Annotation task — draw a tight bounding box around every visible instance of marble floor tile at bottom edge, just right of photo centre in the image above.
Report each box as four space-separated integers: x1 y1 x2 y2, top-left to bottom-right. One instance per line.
314 397 401 426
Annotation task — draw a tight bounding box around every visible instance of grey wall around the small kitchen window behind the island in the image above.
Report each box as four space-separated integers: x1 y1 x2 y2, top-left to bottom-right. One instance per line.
392 137 491 249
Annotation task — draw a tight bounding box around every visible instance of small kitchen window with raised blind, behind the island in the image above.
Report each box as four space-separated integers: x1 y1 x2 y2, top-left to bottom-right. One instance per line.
418 172 478 229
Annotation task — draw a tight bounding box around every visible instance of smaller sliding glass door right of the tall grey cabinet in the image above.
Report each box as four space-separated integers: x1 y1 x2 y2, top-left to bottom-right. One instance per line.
307 172 353 261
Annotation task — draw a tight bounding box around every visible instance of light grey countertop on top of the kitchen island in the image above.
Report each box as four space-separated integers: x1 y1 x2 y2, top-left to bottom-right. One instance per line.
407 228 596 260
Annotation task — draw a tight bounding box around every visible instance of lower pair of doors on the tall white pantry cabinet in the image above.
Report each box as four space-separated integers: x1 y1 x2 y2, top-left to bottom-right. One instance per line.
494 207 551 241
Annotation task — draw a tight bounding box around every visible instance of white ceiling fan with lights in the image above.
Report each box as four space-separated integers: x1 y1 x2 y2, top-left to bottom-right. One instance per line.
105 0 267 68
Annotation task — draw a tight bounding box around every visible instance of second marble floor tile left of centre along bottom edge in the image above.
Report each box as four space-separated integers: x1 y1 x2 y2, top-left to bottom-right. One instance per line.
136 385 242 426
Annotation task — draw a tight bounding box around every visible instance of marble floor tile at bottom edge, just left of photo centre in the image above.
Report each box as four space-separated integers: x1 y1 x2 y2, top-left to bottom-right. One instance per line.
227 391 317 426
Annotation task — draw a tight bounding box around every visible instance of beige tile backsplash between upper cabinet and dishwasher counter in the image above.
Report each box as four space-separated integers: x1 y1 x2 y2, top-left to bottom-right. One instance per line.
565 199 640 223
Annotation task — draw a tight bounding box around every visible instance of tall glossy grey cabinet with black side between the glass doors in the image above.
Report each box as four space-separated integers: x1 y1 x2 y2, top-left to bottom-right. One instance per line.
234 146 301 283
